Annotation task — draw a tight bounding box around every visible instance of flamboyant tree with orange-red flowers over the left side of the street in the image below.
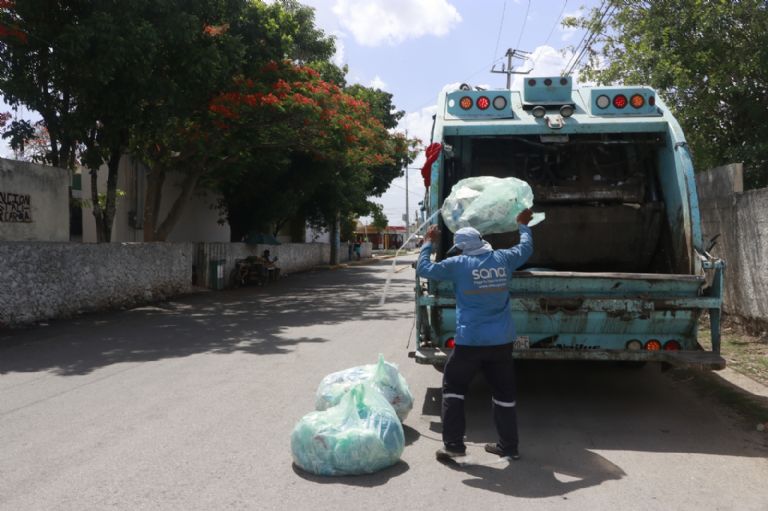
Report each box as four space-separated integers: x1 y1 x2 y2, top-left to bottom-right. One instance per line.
144 61 408 240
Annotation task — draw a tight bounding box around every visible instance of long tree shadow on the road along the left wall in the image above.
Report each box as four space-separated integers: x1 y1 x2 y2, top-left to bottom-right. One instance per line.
0 266 413 376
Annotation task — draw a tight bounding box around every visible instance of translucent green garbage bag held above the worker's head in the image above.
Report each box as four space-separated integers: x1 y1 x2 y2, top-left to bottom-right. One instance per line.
441 176 544 234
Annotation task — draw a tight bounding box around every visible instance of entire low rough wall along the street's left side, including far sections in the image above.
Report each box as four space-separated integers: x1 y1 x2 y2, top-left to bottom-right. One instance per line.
0 237 371 327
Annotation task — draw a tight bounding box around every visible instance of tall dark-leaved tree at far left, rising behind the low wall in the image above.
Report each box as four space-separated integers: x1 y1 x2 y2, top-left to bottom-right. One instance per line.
0 0 247 241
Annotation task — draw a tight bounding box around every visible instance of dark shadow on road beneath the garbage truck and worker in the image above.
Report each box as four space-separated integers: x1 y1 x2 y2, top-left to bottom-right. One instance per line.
422 361 768 499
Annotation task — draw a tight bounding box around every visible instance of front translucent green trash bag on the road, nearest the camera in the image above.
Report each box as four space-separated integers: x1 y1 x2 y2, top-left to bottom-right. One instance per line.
291 383 405 476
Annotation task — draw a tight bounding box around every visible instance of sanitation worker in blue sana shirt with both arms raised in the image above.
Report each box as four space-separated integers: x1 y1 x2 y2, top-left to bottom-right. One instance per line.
416 209 533 461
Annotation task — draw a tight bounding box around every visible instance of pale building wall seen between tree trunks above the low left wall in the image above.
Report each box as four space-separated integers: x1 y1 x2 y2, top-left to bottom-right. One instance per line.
83 156 230 242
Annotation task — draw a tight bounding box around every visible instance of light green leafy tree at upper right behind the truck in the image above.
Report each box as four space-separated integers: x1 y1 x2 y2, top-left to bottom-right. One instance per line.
566 0 768 188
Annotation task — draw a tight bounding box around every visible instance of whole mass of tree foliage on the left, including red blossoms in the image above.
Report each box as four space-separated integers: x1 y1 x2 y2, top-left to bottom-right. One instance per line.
0 0 415 240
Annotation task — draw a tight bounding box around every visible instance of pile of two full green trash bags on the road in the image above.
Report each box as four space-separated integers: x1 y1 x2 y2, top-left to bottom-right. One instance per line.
291 355 413 476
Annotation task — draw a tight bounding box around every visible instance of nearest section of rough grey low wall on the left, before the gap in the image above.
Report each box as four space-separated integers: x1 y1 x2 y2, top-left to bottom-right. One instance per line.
0 242 194 326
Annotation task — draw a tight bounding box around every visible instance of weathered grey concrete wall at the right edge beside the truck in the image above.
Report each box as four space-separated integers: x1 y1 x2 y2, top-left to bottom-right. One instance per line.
696 164 768 329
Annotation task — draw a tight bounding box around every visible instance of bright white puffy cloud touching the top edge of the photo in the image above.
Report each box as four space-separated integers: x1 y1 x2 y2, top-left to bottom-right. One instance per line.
333 0 461 46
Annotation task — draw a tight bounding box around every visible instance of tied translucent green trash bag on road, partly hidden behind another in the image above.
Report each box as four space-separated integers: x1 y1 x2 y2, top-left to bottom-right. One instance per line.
315 354 413 421
